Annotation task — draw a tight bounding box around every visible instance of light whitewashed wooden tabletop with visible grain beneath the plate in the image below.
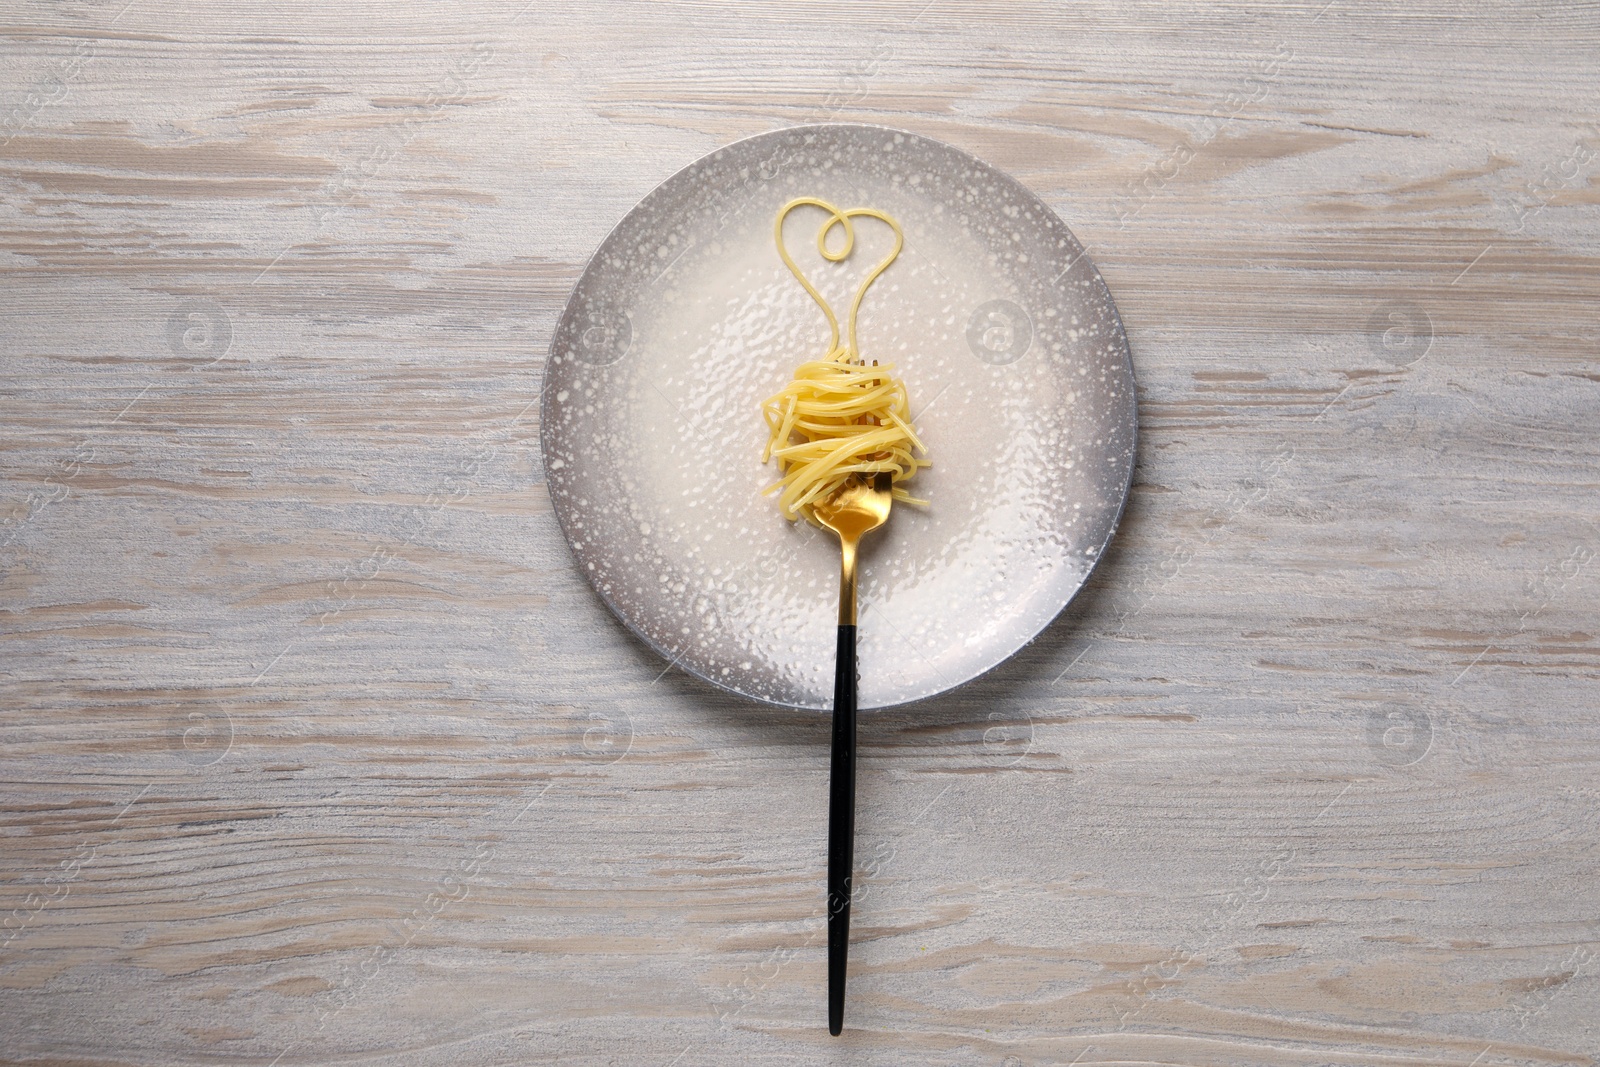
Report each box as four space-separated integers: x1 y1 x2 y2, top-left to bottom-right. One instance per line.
0 0 1600 1067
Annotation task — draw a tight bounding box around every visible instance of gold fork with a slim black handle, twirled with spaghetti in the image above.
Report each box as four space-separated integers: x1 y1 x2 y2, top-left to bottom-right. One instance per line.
813 470 894 1037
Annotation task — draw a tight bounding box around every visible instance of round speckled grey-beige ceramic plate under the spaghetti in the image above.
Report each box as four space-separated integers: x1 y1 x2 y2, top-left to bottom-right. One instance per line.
541 125 1136 709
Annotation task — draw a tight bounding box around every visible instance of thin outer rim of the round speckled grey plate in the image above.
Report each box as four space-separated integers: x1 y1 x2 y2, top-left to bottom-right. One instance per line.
539 122 1139 713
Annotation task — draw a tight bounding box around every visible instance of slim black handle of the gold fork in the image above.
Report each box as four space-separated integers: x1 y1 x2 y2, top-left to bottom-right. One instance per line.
827 625 856 1037
